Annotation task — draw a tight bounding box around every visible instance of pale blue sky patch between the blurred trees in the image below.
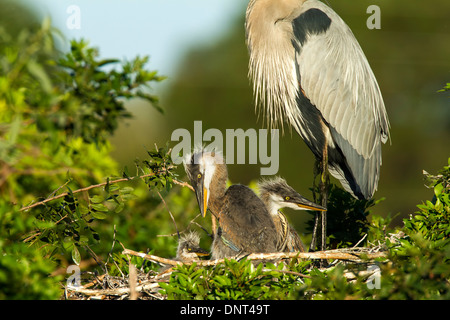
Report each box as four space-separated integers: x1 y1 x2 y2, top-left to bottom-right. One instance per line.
24 0 247 75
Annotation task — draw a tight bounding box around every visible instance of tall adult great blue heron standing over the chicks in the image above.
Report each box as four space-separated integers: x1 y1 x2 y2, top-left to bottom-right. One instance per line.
246 0 389 249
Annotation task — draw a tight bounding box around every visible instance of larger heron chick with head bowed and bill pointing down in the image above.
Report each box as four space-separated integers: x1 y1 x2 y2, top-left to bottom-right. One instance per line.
184 149 277 259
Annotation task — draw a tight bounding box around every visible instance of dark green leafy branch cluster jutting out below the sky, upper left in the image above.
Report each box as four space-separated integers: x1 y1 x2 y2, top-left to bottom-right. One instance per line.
58 40 164 142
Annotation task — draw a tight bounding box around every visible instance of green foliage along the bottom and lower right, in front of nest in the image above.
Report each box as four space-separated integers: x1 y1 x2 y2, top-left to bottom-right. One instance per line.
157 159 450 300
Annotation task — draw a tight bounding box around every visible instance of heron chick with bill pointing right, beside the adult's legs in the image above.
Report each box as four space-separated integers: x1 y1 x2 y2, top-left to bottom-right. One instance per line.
258 177 326 252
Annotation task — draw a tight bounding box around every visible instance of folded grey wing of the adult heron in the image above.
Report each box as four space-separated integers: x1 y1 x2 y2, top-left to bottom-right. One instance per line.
293 1 389 198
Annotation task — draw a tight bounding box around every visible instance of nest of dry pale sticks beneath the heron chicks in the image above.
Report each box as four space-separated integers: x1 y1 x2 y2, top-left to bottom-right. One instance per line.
64 240 386 300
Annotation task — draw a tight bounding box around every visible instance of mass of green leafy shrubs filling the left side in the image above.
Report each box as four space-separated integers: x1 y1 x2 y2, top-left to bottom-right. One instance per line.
0 20 167 299
